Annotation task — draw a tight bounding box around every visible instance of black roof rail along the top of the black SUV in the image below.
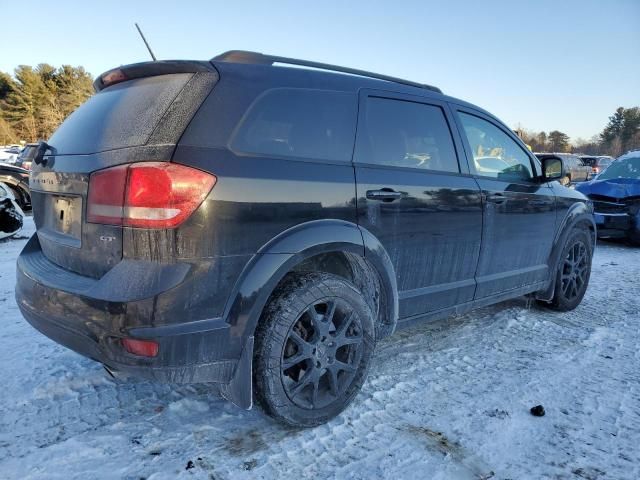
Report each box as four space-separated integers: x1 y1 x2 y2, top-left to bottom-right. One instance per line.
211 50 442 93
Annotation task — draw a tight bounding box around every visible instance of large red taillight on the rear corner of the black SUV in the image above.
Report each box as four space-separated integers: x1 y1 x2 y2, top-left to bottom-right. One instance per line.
87 162 216 228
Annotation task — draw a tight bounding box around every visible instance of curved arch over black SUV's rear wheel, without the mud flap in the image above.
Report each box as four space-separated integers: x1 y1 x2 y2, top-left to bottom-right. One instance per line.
224 220 398 338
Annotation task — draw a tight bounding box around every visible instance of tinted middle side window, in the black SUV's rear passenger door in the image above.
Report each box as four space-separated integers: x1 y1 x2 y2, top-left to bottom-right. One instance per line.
355 97 460 173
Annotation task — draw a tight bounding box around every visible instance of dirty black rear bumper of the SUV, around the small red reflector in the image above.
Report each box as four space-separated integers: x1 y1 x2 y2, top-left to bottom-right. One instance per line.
15 236 243 384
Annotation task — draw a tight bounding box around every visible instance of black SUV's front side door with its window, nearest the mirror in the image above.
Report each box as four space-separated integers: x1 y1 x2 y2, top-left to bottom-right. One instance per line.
457 107 556 299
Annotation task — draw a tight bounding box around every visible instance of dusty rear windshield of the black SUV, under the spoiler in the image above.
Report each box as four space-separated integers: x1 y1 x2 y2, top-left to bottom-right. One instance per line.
49 73 193 154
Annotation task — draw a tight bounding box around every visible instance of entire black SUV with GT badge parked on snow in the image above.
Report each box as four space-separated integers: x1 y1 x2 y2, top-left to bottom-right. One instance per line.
16 51 595 426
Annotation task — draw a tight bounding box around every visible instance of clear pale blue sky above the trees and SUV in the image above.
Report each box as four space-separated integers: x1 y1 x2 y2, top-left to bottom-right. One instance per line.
0 0 640 139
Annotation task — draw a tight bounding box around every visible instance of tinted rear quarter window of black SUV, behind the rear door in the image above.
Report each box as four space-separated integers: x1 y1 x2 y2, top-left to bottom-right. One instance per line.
230 88 357 162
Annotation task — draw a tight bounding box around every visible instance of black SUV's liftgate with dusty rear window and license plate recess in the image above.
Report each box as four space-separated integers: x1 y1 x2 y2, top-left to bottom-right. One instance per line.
29 69 217 278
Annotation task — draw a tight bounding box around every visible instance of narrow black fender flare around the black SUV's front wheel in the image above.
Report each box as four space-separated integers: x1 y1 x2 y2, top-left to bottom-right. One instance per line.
536 202 596 302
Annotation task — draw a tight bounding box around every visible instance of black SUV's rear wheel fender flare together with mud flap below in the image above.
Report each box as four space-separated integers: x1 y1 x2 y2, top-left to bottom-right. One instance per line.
222 219 398 409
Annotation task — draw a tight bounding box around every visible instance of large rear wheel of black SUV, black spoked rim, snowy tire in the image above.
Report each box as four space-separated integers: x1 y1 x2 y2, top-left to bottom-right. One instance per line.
254 273 375 427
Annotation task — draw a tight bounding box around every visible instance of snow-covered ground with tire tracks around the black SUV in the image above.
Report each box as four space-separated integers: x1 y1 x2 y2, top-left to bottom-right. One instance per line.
0 220 640 479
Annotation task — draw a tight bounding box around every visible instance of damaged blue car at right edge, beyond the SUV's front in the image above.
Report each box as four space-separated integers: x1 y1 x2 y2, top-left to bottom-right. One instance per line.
576 150 640 245
